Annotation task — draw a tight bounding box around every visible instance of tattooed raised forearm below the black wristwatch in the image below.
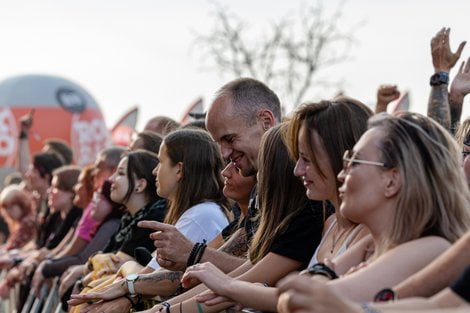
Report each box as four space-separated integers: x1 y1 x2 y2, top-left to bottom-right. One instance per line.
428 85 451 130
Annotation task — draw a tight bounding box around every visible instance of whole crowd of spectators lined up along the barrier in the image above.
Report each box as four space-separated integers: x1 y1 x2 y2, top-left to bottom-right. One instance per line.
0 28 470 313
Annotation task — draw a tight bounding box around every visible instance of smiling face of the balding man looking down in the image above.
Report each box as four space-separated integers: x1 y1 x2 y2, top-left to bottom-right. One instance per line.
206 97 264 176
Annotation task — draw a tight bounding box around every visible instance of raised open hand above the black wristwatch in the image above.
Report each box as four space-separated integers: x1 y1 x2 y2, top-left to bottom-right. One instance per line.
431 27 467 73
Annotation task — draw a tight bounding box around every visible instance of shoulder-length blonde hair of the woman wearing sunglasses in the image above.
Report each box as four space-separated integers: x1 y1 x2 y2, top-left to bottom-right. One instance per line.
369 113 470 253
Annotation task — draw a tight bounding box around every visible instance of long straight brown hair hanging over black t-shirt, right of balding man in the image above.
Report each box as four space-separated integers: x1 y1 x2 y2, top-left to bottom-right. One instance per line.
250 124 308 263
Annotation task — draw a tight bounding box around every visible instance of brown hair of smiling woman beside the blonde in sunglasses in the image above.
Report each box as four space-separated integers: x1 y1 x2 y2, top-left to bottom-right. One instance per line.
286 97 372 187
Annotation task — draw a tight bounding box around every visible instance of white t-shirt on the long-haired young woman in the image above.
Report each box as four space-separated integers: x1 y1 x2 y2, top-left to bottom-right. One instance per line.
147 202 228 270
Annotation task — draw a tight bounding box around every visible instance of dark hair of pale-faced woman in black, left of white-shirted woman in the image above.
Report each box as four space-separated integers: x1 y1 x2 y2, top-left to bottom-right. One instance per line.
122 149 158 202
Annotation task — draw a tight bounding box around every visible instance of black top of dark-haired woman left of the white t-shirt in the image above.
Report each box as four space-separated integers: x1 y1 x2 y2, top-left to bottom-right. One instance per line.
103 199 167 256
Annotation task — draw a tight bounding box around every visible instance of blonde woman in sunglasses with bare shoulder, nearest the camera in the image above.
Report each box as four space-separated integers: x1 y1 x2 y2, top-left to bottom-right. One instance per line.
278 113 470 312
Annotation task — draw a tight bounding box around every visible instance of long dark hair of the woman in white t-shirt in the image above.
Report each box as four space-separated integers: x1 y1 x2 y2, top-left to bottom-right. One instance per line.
163 129 228 224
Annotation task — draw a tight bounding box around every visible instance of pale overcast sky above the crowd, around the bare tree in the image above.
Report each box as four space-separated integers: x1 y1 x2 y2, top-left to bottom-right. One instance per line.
0 0 470 129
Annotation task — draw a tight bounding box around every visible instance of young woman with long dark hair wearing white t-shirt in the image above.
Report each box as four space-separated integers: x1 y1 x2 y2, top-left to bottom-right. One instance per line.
148 129 228 270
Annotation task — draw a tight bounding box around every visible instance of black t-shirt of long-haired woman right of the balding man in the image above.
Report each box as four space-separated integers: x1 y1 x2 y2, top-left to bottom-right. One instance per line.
269 200 331 267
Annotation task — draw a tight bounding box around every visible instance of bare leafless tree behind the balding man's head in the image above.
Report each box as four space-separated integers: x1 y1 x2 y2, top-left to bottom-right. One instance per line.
195 0 359 106
